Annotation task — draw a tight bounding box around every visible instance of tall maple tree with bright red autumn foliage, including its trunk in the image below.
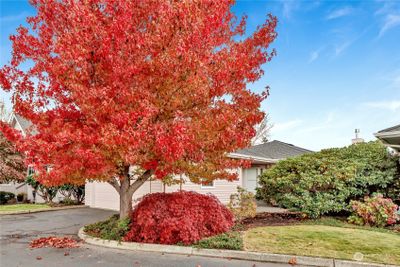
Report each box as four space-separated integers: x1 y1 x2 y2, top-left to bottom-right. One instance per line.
0 0 277 217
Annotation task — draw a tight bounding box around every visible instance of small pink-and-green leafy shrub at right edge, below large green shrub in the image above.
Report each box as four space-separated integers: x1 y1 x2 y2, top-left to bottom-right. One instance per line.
348 194 400 227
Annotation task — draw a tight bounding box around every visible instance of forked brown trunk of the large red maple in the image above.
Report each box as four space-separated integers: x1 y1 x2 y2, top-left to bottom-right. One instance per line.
108 168 152 219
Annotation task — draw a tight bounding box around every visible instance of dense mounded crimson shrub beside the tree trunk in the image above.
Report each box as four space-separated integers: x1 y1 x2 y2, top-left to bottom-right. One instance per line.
124 191 234 244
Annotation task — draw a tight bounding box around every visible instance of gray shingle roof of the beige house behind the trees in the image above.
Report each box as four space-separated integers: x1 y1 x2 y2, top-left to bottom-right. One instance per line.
235 140 313 159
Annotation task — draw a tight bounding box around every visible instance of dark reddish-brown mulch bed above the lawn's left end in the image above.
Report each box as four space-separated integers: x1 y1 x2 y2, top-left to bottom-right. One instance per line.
241 212 306 229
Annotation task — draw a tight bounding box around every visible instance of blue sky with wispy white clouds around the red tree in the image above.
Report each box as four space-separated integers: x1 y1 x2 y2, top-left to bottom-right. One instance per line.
0 0 400 150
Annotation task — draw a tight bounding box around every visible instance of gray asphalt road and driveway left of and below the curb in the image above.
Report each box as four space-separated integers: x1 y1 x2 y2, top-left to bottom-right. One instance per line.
0 208 290 267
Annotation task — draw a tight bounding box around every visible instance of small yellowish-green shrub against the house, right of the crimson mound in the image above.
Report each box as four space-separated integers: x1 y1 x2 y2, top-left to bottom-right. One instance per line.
228 186 257 221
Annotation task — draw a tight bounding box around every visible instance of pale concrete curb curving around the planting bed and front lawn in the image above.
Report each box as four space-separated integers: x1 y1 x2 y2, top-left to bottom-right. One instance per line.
78 227 398 267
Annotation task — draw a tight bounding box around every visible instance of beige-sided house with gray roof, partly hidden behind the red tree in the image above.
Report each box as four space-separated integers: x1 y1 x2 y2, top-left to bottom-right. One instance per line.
85 141 312 210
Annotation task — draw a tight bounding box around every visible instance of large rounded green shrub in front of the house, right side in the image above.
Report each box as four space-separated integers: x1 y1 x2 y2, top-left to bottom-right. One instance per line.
257 142 400 218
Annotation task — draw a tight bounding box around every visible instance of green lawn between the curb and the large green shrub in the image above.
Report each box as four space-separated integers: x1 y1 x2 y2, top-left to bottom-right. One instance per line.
244 225 400 264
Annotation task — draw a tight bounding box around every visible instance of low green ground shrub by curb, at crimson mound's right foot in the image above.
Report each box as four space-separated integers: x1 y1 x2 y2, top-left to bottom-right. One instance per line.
193 232 243 250
